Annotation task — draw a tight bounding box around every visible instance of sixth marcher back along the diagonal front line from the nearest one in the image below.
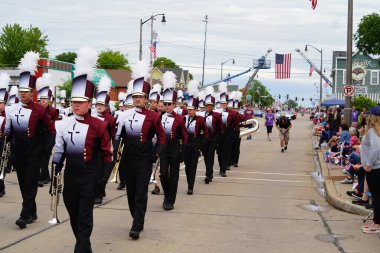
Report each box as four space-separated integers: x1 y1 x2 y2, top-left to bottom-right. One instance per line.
218 83 239 177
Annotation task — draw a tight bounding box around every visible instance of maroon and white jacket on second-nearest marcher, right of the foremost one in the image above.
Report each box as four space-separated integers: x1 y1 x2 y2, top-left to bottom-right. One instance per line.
115 108 166 160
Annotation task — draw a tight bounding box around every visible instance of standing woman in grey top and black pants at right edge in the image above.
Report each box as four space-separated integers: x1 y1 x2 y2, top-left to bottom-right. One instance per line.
361 106 380 234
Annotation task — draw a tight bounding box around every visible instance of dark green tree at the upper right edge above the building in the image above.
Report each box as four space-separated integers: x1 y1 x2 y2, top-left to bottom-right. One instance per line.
354 13 380 55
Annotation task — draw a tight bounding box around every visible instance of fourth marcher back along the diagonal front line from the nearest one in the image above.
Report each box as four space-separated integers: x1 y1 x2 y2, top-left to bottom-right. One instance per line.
183 81 208 195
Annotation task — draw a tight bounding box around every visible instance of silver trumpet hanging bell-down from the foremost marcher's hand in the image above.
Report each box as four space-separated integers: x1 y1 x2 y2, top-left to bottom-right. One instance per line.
49 164 63 224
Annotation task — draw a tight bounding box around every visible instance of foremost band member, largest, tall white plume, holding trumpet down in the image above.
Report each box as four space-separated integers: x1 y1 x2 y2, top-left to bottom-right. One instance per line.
53 48 112 253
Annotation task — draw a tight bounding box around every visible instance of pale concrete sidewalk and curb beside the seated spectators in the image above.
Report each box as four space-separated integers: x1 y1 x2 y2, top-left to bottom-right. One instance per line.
314 140 371 215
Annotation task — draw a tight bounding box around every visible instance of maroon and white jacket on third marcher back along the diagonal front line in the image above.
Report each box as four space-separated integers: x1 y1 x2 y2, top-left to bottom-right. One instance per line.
161 112 187 147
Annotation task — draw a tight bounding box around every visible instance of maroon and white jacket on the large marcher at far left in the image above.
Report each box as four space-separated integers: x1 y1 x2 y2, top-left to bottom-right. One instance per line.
5 101 55 142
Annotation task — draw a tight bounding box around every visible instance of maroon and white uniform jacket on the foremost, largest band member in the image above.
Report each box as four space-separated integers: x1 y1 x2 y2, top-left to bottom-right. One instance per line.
53 114 112 171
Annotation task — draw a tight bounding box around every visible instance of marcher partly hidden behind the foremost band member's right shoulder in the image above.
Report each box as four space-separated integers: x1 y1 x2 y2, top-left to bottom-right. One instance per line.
95 76 117 205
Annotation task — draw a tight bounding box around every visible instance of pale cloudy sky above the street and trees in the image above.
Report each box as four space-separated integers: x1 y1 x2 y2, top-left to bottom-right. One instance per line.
0 0 380 106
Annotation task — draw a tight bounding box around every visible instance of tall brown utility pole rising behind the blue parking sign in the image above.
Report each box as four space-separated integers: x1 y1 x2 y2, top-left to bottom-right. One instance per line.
344 0 353 126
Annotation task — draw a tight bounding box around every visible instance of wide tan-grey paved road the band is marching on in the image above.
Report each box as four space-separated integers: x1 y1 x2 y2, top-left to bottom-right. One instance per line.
0 116 380 253
